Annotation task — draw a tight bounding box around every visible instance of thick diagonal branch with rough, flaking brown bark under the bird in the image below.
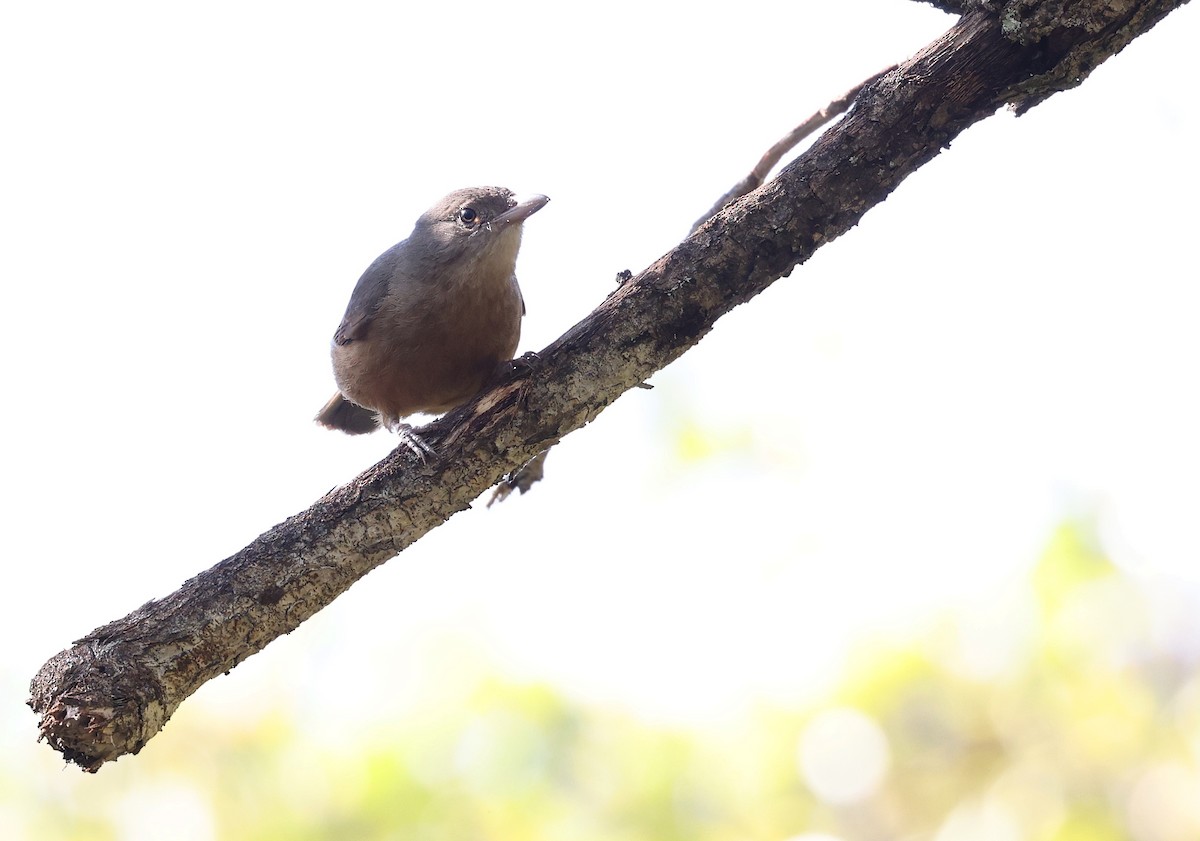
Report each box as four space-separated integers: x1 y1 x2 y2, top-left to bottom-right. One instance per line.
29 0 1186 771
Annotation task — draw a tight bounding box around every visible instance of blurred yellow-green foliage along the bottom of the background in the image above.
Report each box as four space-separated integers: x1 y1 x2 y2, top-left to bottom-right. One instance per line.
11 523 1200 841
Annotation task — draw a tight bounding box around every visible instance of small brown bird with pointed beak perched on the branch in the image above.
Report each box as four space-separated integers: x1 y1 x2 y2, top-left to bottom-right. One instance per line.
316 187 550 443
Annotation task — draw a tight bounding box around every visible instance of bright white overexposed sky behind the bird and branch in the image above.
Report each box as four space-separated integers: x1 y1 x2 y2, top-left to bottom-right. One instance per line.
0 0 1200 765
